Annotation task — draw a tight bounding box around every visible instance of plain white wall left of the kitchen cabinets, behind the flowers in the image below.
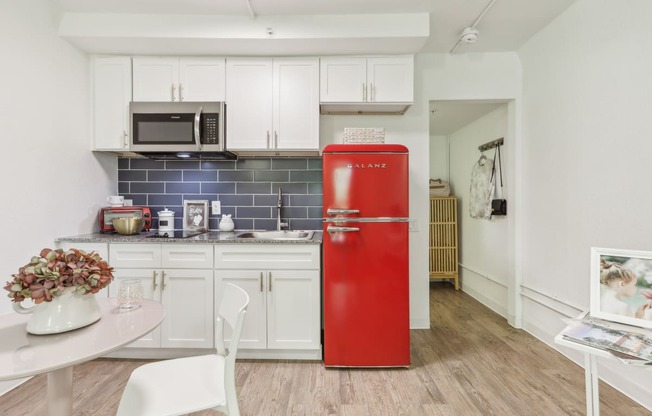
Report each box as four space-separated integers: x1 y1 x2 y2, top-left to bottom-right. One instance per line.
0 0 117 313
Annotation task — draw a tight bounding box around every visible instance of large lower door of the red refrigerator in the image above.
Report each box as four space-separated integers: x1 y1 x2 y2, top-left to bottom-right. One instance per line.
323 222 410 367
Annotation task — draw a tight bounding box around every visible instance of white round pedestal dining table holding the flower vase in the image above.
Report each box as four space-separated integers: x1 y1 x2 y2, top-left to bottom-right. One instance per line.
0 298 165 416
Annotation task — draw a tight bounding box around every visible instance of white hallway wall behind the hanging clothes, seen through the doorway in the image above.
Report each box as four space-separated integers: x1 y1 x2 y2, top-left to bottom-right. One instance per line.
450 104 513 317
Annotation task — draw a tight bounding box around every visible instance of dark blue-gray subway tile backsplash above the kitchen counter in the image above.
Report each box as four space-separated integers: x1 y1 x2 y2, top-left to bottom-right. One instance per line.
118 158 323 230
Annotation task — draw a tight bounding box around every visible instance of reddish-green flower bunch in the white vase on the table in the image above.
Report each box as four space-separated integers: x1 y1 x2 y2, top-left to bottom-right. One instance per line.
4 248 113 304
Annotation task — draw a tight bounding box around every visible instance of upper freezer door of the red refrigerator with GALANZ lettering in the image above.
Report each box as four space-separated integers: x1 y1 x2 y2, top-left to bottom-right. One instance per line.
323 153 409 218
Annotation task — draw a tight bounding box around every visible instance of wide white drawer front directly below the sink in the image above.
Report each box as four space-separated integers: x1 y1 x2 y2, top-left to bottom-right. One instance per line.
215 244 320 270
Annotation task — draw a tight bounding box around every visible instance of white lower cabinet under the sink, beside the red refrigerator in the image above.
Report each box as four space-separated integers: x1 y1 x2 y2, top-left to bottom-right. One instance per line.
215 244 321 359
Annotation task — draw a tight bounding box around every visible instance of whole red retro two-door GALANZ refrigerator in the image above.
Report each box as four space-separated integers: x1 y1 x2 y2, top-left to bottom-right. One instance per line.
323 144 410 367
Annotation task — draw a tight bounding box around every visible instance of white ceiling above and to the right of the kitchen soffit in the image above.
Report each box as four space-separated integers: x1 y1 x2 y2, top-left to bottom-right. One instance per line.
57 0 574 54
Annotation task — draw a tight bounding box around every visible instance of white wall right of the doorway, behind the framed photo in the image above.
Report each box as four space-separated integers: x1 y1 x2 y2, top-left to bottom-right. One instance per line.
519 0 652 409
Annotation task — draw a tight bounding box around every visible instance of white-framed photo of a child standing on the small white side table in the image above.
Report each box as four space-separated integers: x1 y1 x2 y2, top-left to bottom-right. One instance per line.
590 247 652 328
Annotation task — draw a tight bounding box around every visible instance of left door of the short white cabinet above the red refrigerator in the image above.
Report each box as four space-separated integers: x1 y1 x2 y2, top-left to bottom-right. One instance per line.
319 58 367 103
